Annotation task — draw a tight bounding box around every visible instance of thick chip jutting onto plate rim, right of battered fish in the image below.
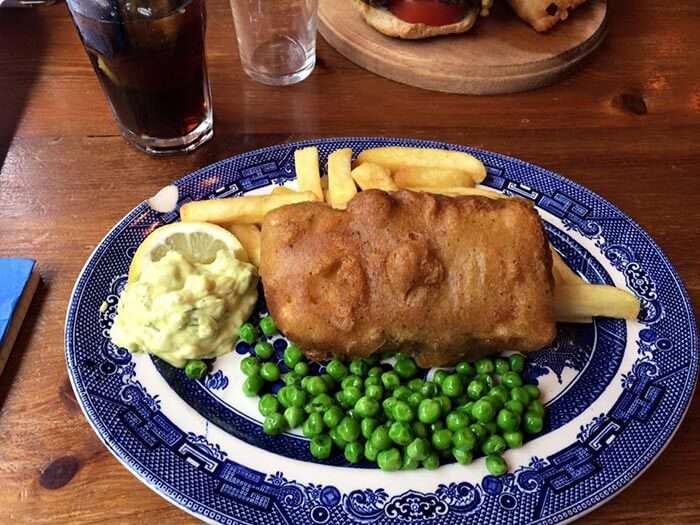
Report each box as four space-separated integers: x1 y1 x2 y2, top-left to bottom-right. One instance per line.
554 284 640 322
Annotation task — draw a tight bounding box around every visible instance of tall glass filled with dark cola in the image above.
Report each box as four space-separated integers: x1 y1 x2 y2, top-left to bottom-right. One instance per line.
67 0 214 155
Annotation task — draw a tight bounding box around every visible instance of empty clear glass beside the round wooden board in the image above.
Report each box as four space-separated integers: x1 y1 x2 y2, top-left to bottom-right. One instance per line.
230 0 318 86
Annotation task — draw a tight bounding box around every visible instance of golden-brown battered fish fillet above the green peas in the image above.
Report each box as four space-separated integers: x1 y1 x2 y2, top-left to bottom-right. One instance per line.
260 190 555 367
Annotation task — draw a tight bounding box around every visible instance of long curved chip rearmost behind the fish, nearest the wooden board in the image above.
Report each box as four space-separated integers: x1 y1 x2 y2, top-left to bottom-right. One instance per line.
357 146 486 184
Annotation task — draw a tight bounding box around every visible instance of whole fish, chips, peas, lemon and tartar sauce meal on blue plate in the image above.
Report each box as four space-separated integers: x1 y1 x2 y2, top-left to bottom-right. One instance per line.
111 142 640 476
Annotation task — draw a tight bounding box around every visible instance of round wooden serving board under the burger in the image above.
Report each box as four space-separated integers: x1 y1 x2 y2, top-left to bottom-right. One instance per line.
319 0 607 95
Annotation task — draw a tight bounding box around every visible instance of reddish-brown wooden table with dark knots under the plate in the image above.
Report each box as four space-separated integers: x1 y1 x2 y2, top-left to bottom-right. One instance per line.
0 0 700 525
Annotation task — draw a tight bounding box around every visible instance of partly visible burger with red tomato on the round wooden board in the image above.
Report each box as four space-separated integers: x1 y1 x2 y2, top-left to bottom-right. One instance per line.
352 0 493 40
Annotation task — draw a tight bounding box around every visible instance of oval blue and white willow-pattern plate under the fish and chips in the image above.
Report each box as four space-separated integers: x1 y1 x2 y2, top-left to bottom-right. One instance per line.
65 138 698 525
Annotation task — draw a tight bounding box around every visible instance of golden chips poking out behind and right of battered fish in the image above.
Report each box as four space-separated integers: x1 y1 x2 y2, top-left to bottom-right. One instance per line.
180 147 640 323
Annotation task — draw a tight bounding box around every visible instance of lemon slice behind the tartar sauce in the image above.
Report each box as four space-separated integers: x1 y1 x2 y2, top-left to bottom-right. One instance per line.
128 222 248 283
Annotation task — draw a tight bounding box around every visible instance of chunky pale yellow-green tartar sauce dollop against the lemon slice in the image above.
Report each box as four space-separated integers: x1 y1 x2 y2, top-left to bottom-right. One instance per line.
110 250 258 368
